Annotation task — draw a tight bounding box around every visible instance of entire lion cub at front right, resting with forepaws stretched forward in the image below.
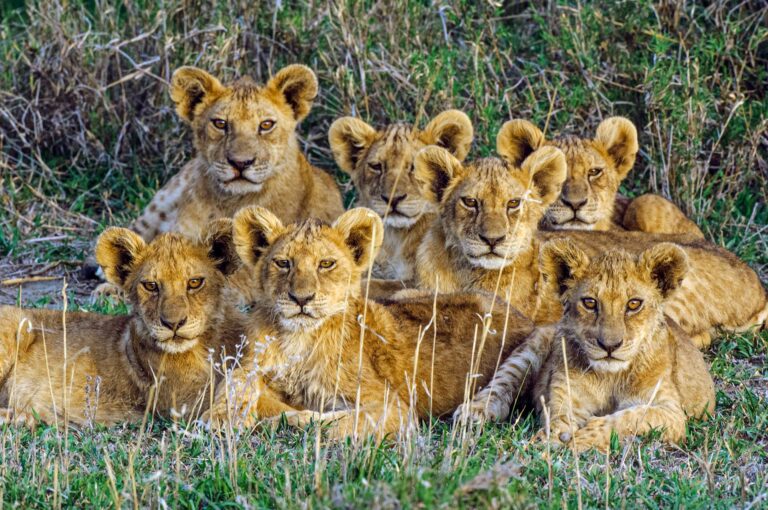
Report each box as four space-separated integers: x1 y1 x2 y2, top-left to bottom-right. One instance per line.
462 240 715 450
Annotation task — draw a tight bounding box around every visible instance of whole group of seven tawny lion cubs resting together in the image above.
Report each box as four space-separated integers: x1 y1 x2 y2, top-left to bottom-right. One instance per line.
0 65 768 449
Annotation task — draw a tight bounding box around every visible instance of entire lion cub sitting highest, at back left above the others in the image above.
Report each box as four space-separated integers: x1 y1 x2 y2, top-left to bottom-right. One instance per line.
133 65 344 241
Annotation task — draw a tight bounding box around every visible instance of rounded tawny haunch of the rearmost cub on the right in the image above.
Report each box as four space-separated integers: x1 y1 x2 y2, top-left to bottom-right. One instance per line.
622 193 704 239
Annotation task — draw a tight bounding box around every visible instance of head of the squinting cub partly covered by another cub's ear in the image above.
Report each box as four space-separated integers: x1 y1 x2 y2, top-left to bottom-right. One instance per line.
328 110 474 229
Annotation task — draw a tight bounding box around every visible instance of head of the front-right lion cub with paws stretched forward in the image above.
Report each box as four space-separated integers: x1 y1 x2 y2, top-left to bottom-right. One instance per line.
540 239 688 372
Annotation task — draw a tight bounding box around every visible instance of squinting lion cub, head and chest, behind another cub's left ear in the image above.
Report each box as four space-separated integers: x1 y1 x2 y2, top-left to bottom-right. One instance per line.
328 110 474 282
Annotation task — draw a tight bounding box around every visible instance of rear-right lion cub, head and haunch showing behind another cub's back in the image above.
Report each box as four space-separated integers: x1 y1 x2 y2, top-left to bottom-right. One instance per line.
497 117 703 237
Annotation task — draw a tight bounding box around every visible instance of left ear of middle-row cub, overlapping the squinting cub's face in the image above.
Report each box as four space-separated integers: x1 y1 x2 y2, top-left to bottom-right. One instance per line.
413 146 464 204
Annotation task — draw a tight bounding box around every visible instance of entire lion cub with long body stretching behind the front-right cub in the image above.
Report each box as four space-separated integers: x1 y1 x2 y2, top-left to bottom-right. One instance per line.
416 146 768 347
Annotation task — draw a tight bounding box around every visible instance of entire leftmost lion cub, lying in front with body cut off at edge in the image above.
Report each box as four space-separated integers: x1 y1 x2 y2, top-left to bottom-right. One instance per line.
0 220 242 425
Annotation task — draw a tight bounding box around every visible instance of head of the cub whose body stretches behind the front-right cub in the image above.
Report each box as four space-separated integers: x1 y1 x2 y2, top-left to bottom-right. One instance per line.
416 147 565 269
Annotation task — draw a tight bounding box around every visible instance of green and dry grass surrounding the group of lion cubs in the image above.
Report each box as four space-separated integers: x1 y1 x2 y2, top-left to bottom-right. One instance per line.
0 0 768 508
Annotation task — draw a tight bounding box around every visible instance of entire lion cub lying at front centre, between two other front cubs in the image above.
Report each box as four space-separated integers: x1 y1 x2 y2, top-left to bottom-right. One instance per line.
209 207 533 438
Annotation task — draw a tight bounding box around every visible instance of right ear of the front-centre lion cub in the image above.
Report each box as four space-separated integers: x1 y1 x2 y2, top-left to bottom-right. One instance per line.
333 207 384 269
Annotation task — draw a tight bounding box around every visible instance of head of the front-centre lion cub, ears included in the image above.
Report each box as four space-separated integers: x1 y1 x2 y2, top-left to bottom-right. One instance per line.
234 207 384 331
